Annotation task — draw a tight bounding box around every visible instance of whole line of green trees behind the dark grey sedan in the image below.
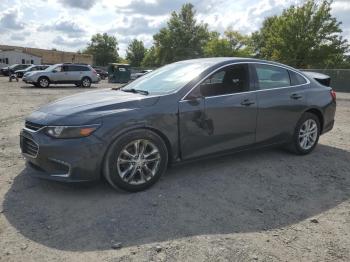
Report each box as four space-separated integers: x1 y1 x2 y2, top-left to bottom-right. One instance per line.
83 0 350 68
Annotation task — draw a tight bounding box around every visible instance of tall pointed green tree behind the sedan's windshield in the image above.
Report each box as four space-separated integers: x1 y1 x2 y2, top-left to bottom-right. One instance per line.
153 4 209 65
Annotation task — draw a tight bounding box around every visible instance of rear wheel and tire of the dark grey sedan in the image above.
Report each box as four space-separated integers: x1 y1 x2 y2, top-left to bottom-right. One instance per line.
290 113 321 155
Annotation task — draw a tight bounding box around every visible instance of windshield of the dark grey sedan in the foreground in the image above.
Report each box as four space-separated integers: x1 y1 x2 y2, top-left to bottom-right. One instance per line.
121 61 213 94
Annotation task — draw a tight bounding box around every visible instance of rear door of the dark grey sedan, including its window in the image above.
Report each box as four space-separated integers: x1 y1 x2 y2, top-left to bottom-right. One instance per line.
254 64 308 143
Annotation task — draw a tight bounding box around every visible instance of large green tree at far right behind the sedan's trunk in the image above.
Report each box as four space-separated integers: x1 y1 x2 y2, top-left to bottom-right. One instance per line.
252 0 349 68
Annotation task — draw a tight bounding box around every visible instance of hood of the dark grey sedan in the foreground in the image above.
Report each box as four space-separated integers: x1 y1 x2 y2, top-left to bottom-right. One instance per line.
34 89 158 116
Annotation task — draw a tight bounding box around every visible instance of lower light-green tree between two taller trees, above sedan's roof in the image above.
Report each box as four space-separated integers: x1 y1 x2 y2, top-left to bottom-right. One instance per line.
203 28 252 57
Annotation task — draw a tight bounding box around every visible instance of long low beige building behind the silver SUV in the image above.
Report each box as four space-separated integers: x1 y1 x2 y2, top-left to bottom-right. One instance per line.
0 45 93 65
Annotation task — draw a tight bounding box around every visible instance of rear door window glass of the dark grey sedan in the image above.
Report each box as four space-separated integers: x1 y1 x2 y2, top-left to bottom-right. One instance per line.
255 64 290 90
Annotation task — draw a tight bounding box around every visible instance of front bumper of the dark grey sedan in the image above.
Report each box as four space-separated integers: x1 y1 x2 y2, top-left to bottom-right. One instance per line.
20 128 104 182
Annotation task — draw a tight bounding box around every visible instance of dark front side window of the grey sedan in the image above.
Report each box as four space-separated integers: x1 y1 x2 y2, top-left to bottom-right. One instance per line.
199 64 250 97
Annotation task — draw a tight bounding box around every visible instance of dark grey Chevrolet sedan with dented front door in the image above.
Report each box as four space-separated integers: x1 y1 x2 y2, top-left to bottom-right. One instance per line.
20 58 336 191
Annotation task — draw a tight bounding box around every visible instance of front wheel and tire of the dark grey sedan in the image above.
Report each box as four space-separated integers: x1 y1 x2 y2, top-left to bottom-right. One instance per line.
103 129 168 192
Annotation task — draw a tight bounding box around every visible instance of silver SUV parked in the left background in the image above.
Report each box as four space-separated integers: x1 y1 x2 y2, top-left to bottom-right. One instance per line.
23 64 101 88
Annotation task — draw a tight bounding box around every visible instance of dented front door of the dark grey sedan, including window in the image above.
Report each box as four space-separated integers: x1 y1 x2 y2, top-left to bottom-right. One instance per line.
179 64 257 159
